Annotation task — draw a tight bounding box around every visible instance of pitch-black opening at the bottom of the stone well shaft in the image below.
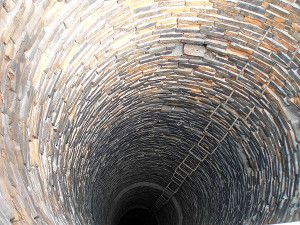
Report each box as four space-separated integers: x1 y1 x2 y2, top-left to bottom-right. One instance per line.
119 208 158 225
